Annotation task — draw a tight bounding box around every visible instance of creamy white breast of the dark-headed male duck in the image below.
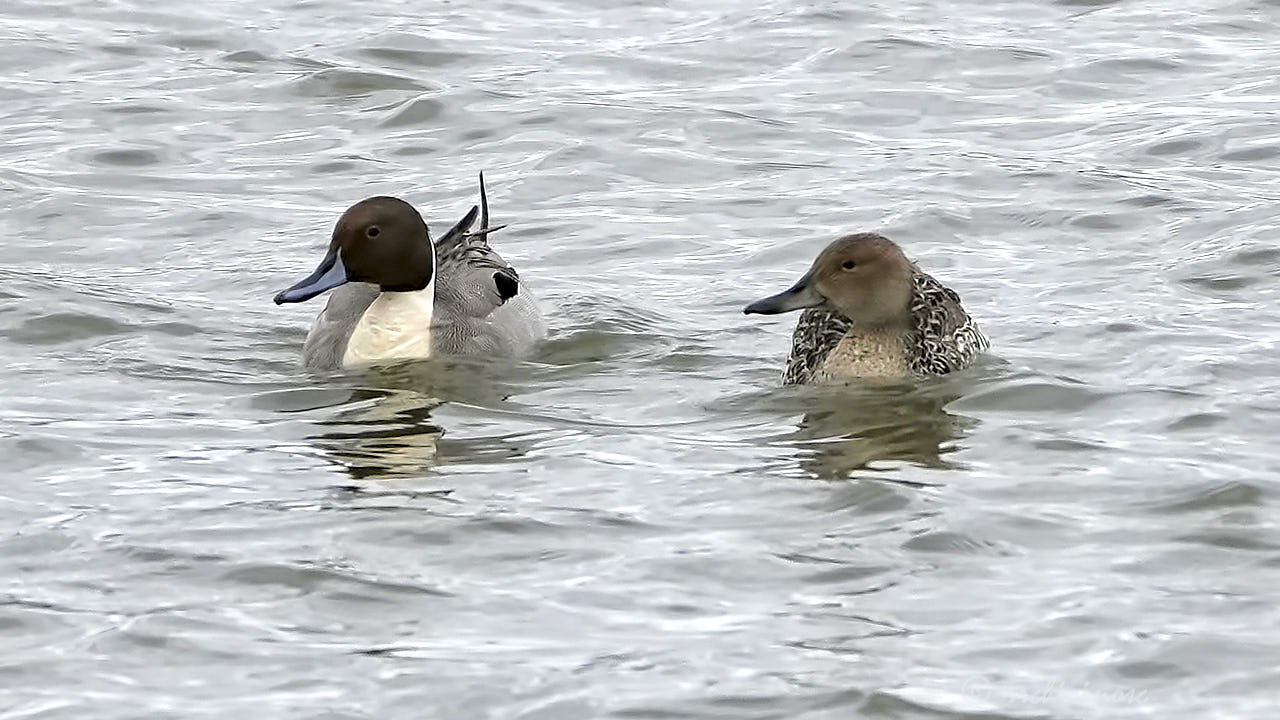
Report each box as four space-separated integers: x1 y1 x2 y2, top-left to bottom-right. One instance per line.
342 278 435 368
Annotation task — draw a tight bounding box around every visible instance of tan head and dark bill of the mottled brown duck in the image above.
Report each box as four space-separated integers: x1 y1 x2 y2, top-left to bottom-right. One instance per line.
744 233 913 328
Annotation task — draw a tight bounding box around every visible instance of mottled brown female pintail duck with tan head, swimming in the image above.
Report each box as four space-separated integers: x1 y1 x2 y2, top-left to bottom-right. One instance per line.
744 233 989 384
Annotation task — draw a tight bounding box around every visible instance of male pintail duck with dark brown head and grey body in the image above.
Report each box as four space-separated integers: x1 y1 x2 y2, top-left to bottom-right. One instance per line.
275 174 547 370
